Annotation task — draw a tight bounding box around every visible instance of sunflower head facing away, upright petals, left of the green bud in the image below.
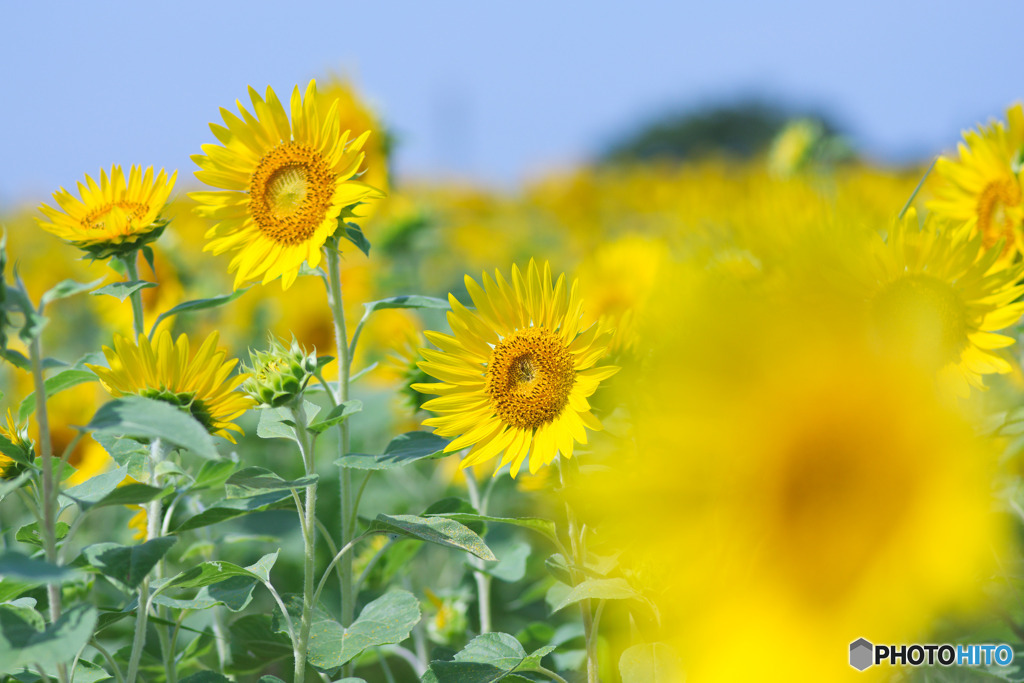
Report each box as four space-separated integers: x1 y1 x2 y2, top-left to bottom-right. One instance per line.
88 332 255 443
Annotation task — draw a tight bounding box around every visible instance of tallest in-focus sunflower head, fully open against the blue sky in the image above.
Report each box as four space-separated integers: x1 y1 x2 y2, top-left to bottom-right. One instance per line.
189 81 383 289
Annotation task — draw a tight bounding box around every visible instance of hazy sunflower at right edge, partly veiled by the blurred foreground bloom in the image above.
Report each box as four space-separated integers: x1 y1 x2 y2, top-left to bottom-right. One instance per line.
855 210 1024 396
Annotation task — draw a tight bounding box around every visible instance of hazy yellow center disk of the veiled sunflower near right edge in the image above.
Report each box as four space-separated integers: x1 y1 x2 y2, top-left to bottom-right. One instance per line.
871 275 968 367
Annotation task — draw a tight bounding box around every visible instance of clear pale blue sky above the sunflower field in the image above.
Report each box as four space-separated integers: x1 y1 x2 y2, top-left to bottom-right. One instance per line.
0 0 1024 204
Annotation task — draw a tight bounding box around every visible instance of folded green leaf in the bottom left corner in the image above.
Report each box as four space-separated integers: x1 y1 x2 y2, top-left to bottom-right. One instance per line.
0 604 97 674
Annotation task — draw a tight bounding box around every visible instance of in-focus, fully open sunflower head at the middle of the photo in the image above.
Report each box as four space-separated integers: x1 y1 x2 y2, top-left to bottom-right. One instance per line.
413 260 618 477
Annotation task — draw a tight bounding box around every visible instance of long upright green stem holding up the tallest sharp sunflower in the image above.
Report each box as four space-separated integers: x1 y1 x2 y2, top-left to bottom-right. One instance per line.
326 240 356 626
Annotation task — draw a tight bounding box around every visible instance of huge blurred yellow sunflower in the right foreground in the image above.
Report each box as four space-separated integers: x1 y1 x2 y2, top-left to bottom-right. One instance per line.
573 282 1009 683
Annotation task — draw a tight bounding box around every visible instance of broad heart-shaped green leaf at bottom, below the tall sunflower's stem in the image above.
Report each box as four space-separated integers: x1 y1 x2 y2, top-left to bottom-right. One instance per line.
307 591 420 671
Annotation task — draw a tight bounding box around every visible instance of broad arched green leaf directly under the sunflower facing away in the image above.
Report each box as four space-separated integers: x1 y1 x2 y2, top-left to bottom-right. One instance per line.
87 396 219 460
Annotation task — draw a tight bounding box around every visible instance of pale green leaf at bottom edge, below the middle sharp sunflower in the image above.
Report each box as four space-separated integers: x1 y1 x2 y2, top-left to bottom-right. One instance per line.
430 633 555 683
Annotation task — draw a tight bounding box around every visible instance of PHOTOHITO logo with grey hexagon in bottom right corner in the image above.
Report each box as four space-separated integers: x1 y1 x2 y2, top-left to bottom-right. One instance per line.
850 638 1014 671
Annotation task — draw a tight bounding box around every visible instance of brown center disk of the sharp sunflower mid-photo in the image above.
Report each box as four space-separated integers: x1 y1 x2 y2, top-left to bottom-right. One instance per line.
486 328 575 429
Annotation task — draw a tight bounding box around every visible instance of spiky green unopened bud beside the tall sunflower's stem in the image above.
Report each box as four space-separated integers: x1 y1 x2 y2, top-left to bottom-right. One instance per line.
242 336 316 408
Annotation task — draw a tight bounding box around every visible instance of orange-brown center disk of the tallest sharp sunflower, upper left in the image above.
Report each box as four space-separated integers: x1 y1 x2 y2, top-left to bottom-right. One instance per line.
249 142 335 245
